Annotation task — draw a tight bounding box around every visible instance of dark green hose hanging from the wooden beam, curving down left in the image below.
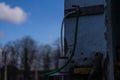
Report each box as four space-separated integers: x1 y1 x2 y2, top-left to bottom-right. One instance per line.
45 8 79 76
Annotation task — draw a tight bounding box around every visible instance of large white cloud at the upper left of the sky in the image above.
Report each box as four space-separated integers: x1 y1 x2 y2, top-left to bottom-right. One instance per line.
0 2 27 24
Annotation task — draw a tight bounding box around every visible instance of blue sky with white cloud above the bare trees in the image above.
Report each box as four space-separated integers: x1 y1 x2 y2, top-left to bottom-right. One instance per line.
0 0 64 44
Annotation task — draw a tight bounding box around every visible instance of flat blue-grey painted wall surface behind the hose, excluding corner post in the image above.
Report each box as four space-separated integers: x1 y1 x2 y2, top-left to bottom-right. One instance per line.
64 0 106 65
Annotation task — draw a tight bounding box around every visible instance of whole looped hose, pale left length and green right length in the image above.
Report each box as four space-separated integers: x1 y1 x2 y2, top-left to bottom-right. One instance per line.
45 8 79 76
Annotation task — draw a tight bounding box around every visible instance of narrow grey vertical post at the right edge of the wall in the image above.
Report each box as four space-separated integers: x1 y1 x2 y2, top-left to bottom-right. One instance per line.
107 0 114 80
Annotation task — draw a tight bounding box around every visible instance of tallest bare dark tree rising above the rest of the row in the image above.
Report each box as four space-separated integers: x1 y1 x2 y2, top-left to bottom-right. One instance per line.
19 36 37 80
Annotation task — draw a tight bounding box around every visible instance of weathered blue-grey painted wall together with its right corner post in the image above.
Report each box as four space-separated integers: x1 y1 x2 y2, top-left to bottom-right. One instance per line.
64 0 114 80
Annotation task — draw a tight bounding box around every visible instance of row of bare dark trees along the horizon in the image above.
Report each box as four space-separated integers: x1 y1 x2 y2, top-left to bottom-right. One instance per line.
0 36 60 78
